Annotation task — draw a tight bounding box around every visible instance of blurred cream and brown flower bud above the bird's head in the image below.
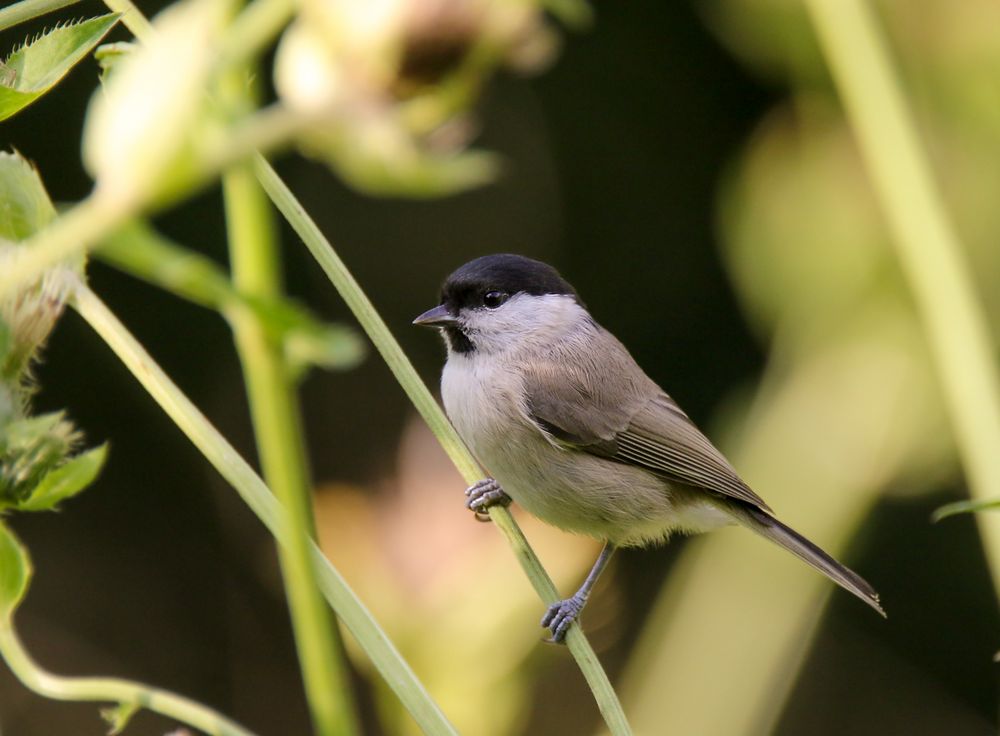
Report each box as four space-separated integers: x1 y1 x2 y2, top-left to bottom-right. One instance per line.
275 0 555 196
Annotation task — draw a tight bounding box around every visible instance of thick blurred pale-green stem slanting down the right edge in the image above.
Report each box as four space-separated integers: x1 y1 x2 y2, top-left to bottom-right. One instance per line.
806 0 1000 592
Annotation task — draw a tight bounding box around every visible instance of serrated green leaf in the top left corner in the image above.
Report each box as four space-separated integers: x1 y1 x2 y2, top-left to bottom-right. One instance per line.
0 13 121 120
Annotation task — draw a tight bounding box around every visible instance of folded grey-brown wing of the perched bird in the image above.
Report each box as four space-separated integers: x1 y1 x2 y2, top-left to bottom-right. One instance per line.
524 332 770 511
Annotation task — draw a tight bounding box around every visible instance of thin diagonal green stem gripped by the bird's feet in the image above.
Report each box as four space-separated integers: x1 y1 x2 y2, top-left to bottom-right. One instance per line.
254 155 631 736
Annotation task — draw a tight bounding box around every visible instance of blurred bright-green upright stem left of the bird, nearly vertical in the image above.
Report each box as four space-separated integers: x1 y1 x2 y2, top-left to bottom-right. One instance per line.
220 60 358 736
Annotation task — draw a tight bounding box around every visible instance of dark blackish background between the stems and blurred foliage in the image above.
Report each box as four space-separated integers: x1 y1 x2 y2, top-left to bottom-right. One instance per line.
0 0 1000 736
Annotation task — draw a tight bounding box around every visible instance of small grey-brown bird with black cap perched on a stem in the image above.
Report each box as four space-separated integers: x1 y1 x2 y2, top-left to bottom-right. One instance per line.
413 254 885 643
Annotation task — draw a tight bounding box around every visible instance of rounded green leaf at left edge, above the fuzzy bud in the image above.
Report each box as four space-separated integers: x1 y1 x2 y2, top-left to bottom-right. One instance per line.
0 150 56 243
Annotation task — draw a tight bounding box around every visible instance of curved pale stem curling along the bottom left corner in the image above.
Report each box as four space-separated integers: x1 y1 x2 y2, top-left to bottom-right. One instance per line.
0 622 253 736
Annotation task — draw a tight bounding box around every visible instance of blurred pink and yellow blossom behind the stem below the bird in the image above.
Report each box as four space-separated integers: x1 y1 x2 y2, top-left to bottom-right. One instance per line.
317 421 598 736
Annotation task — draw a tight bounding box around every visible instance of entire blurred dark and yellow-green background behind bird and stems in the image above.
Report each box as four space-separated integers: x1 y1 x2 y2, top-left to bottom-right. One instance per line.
0 0 1000 736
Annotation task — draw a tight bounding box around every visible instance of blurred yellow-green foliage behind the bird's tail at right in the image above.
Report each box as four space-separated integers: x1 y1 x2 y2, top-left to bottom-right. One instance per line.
627 0 1000 736
